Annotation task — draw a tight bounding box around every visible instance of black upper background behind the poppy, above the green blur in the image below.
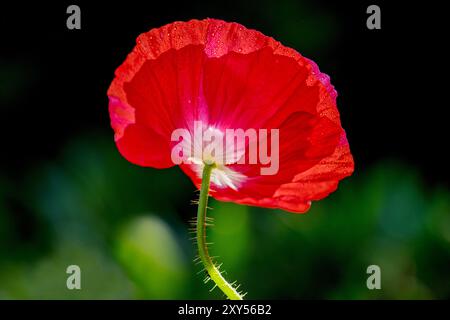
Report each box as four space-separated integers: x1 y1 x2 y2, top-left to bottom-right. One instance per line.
1 0 449 182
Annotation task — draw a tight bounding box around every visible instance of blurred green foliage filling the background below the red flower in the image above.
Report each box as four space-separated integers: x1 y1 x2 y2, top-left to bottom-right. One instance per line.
0 133 450 299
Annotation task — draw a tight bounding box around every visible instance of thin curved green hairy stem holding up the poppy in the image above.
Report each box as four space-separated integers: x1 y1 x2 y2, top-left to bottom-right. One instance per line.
197 164 243 300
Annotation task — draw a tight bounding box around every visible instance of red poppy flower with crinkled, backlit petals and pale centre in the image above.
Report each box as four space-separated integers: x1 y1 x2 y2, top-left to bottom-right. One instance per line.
108 19 353 212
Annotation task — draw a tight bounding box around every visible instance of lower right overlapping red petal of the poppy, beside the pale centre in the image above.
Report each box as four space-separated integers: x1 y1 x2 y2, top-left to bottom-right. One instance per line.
182 110 354 213
